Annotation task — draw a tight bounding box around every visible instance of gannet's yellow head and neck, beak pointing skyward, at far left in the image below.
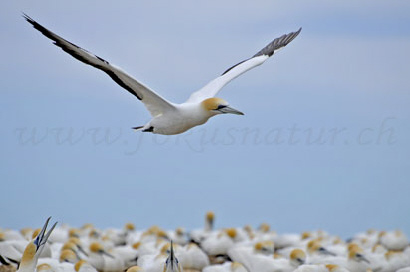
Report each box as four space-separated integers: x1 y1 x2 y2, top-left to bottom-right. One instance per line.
18 217 57 272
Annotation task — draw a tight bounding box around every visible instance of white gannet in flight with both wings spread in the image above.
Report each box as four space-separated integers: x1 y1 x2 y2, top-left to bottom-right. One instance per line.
23 14 301 135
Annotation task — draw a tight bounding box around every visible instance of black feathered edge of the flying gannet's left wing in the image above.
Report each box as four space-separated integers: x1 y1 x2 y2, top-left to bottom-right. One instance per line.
23 13 143 100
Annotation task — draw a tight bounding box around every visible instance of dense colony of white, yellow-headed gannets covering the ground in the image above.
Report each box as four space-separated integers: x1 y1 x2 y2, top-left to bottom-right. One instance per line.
0 212 410 272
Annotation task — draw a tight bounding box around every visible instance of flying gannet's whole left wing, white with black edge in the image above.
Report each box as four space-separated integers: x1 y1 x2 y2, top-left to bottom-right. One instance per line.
23 13 174 116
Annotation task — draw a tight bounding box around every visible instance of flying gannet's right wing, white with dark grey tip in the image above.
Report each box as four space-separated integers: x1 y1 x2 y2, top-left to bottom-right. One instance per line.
187 28 302 102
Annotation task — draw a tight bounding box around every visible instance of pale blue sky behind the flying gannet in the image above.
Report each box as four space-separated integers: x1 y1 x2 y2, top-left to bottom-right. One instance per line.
0 0 410 237
